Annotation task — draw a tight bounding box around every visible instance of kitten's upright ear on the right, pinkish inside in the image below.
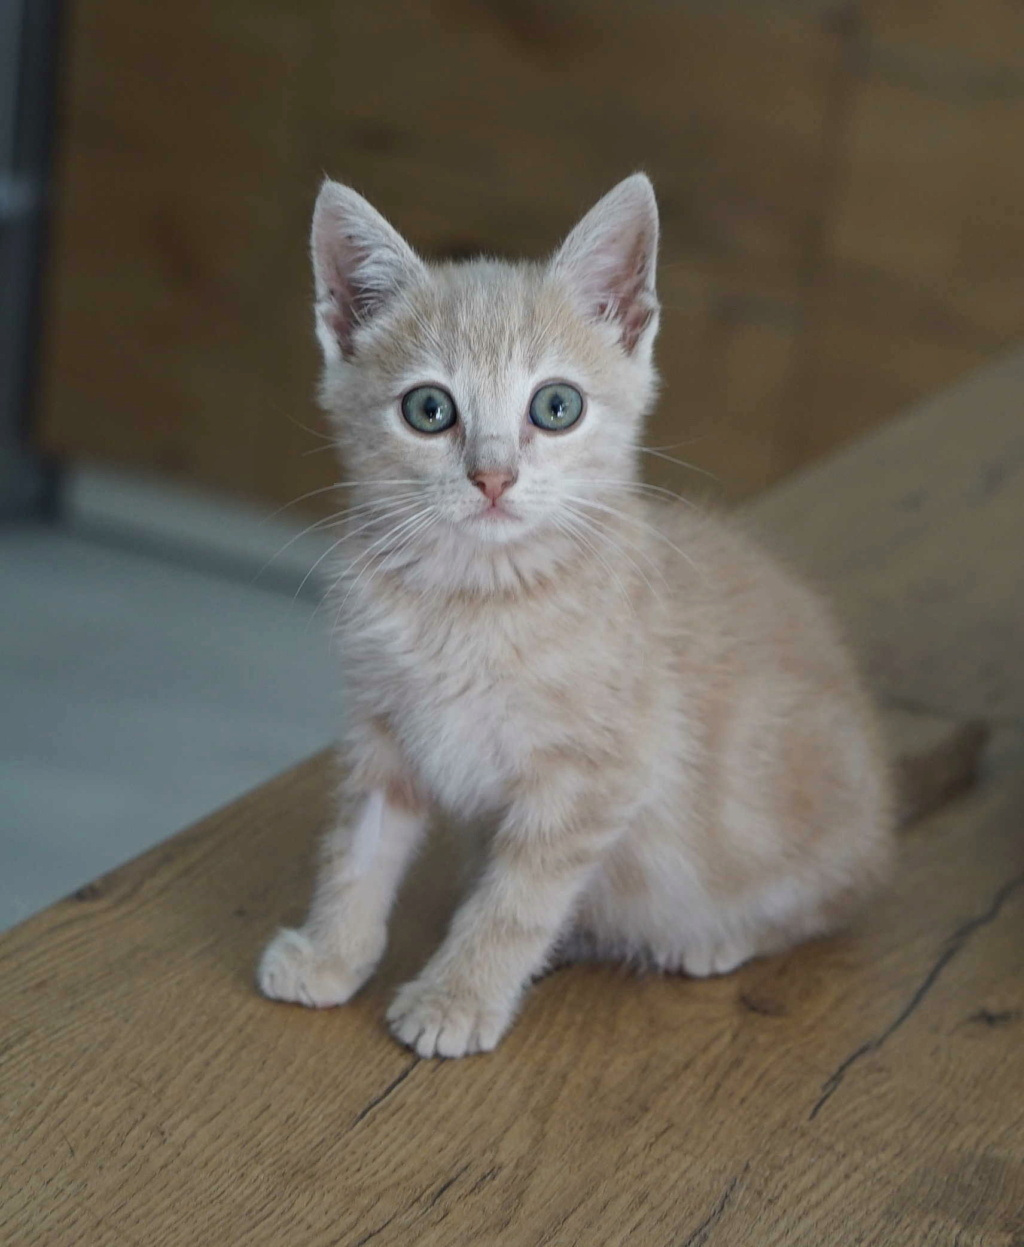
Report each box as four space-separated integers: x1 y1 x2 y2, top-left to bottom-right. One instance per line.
553 173 657 354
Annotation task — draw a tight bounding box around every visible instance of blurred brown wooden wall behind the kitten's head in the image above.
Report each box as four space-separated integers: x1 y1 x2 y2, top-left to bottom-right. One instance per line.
41 0 1022 511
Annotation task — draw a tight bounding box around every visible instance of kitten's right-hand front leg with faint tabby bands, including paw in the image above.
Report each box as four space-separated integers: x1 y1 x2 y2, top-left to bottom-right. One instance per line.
388 776 617 1056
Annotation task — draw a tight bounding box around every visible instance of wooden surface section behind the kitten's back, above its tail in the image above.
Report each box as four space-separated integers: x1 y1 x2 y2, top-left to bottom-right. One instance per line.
751 349 1024 725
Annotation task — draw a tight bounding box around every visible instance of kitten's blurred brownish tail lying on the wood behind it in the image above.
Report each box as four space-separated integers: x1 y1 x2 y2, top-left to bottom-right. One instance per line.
882 708 990 827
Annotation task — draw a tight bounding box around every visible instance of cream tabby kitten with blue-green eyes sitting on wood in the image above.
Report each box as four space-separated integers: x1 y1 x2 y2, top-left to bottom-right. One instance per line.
258 175 893 1056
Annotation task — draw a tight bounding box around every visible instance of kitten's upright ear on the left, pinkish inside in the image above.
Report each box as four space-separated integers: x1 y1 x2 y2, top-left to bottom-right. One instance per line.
309 180 425 363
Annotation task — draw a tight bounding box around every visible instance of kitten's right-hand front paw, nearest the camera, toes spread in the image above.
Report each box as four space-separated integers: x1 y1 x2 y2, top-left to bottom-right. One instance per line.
388 979 513 1056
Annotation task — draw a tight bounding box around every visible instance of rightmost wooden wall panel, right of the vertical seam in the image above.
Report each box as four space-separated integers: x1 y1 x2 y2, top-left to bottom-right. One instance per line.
791 7 1024 459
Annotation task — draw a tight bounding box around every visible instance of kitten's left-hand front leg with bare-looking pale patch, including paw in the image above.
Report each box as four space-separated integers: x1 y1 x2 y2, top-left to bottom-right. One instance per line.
263 788 425 1008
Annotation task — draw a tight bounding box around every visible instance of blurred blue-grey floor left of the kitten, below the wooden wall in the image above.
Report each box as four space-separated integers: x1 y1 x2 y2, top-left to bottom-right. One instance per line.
0 473 338 928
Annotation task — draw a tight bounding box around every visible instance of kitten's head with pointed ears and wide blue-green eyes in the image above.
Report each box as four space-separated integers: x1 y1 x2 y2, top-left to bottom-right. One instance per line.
312 173 659 546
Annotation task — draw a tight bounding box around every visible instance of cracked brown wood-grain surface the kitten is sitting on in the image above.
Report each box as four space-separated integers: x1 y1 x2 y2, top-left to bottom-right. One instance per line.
0 355 1024 1247
